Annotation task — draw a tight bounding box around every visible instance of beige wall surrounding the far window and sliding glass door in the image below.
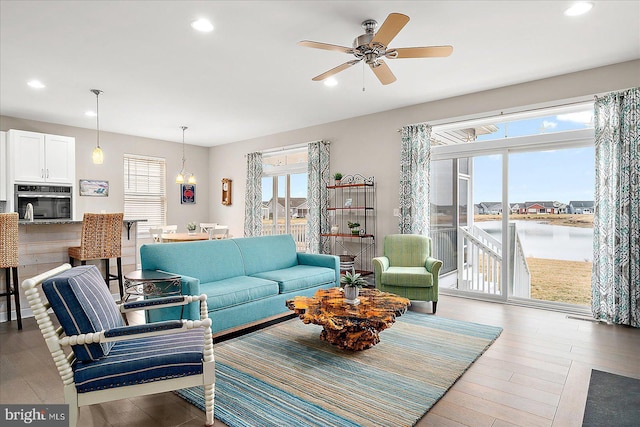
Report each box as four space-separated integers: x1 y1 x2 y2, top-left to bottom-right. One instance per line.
209 60 640 253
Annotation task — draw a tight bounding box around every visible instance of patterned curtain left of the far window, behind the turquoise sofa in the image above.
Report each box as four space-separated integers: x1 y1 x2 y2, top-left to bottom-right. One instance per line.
244 153 262 237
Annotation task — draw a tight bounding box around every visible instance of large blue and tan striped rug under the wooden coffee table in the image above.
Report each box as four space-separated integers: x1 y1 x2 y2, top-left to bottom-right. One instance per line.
177 312 502 427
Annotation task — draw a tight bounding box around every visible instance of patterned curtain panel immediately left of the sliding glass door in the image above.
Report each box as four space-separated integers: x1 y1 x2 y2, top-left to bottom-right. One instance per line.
399 124 431 236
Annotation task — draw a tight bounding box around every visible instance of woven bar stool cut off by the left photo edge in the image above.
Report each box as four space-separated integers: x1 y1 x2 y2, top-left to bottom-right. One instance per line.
0 212 22 329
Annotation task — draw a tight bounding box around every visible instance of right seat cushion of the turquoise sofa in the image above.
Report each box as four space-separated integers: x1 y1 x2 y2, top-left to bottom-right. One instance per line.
253 265 336 294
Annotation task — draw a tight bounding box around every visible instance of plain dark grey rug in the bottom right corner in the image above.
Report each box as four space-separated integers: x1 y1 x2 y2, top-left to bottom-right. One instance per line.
582 369 640 427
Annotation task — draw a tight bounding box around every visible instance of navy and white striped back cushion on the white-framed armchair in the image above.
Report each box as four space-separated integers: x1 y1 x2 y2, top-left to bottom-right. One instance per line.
42 265 124 361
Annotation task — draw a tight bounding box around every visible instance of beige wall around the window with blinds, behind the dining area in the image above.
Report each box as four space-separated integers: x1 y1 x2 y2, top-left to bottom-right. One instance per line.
0 116 211 232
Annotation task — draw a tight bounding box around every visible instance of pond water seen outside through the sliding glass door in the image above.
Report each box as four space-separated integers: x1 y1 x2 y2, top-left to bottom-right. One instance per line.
475 221 593 262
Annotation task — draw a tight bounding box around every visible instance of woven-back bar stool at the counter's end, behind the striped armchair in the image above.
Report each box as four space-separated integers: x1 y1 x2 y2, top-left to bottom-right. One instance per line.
69 213 124 299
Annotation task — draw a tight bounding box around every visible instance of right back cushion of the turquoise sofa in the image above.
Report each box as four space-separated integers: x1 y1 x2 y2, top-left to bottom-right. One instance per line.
232 234 298 276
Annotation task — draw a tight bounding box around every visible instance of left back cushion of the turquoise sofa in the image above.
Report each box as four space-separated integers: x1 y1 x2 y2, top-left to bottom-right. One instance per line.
140 239 245 283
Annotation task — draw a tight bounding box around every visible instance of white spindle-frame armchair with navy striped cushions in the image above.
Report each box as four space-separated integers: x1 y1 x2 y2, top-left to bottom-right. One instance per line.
22 264 215 427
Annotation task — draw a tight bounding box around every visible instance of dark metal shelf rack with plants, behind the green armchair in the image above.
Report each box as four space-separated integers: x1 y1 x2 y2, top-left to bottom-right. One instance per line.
322 174 376 275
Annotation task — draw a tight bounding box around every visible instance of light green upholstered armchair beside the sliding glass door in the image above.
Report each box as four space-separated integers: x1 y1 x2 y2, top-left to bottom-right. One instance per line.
373 234 442 314
